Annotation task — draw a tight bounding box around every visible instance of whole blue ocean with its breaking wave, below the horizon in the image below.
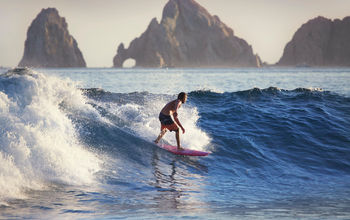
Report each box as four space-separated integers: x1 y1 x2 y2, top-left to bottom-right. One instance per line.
0 68 350 219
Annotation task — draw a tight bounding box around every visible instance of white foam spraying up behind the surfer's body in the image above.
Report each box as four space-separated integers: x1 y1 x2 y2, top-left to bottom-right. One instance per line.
99 97 210 150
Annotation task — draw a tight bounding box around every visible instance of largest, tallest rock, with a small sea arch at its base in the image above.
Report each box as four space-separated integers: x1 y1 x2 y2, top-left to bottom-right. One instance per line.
113 0 260 67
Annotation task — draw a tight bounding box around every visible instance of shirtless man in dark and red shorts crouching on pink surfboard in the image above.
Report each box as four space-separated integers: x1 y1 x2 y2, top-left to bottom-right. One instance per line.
154 92 187 150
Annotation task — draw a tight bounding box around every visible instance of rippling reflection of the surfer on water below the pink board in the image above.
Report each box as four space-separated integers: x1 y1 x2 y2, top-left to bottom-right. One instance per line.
151 149 208 211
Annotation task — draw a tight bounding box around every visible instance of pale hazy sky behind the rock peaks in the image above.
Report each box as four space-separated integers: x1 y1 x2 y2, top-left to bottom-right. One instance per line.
0 0 350 67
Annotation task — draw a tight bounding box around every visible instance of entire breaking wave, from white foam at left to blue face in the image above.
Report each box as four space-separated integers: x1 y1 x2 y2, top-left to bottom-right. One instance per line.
0 69 350 200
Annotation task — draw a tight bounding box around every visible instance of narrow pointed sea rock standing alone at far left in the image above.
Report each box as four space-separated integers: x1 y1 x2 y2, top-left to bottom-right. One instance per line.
19 8 86 67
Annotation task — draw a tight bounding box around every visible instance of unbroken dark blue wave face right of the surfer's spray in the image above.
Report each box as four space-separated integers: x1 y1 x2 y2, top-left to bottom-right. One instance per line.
190 87 350 178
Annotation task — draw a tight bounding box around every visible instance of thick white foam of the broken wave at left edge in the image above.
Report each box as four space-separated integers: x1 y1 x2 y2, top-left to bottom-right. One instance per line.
0 69 99 201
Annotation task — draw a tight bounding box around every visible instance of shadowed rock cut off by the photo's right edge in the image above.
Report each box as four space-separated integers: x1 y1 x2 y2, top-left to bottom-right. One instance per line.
277 17 350 66
